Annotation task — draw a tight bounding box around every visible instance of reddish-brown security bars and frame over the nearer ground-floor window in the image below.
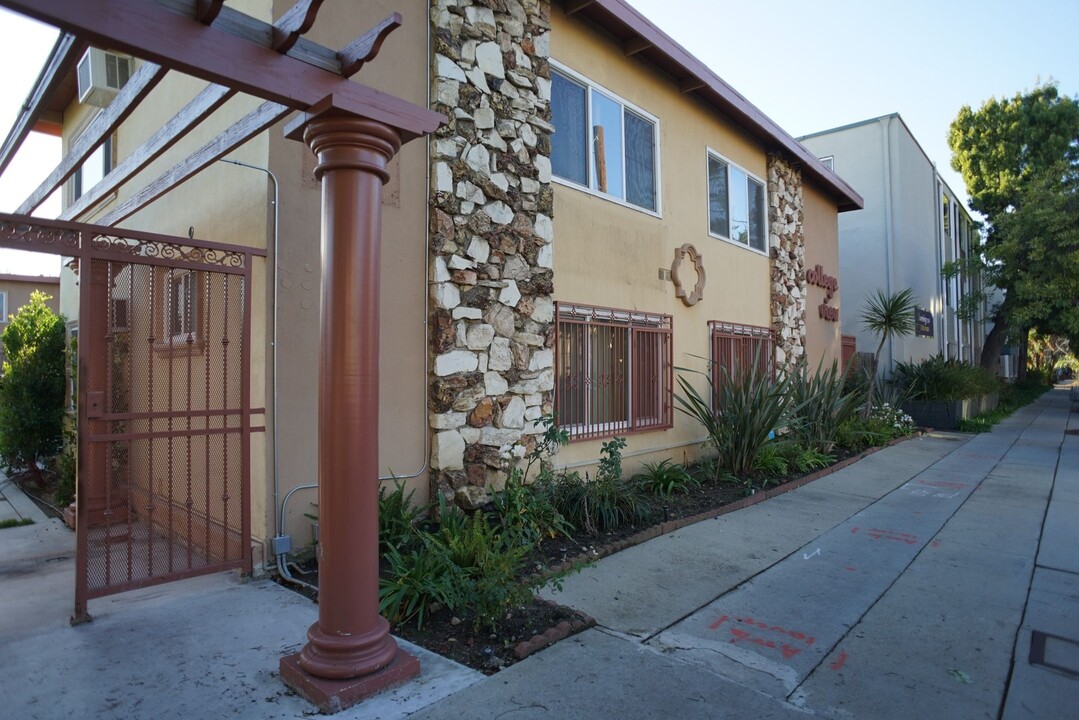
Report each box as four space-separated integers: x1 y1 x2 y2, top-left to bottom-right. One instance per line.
555 301 674 443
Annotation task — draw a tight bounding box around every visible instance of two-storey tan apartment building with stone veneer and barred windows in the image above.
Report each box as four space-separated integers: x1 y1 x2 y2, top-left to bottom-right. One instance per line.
14 0 862 563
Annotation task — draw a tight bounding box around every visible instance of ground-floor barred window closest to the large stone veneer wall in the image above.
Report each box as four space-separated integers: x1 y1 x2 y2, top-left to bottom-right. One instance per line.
555 302 674 439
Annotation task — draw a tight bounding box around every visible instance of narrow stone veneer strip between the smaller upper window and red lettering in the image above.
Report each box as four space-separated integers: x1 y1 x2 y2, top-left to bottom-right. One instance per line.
768 154 806 372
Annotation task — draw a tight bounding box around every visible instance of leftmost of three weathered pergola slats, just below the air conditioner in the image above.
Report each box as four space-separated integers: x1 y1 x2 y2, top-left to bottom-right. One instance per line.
15 63 166 215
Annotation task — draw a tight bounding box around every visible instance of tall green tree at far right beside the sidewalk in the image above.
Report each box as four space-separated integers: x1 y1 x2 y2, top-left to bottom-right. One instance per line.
948 83 1079 372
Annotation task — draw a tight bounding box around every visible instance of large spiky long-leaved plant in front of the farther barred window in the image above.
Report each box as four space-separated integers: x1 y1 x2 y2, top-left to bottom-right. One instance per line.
674 354 794 479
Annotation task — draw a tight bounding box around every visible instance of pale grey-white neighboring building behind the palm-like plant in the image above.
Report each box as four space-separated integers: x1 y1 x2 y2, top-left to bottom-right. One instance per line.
798 113 986 375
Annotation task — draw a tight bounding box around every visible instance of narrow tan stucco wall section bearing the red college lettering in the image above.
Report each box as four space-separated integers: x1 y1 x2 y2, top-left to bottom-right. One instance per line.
802 182 849 370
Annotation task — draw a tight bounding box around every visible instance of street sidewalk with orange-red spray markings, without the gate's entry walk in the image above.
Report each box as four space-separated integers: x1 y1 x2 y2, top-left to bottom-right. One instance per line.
415 390 1079 720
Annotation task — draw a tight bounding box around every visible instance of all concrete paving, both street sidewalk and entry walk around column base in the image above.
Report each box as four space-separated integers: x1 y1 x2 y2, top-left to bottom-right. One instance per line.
0 391 1079 720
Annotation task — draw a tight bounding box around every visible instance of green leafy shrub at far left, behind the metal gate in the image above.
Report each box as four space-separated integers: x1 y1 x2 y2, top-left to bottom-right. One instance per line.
0 291 66 487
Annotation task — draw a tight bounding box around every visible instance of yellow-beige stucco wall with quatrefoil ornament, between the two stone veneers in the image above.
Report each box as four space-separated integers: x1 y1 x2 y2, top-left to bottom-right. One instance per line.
551 4 771 471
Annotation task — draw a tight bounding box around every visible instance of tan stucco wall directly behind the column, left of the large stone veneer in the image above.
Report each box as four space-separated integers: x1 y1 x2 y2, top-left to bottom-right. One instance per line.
268 0 428 546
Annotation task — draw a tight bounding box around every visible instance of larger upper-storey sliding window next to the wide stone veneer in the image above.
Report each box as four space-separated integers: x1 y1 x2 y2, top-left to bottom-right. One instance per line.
550 67 659 213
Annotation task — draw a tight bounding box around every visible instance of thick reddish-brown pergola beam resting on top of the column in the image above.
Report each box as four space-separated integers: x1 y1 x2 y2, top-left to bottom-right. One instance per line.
0 0 442 140
